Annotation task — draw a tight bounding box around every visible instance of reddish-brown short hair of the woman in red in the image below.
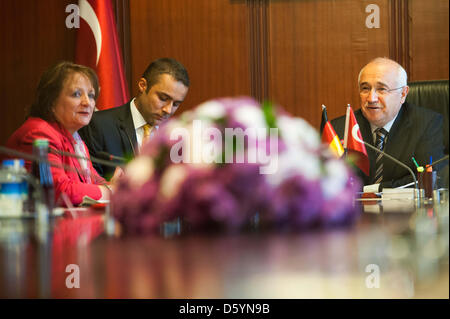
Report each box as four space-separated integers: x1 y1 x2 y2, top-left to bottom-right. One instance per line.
29 61 99 122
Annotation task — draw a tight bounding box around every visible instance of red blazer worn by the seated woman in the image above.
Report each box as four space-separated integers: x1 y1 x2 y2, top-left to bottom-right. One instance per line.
7 117 106 205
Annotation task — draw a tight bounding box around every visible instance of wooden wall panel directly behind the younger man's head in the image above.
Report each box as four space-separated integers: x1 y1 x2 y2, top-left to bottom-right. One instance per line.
130 0 251 110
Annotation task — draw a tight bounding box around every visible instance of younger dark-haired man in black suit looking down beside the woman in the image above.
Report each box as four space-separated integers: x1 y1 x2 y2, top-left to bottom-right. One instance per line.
79 58 189 179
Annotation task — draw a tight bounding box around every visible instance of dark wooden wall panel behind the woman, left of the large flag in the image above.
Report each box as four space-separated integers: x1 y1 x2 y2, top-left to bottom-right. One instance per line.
0 0 75 145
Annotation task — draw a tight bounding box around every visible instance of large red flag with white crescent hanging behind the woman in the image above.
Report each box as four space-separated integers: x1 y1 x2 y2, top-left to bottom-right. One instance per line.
75 0 129 110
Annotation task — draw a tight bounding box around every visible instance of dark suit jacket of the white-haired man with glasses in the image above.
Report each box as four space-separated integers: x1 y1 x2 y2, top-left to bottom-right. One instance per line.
331 103 444 188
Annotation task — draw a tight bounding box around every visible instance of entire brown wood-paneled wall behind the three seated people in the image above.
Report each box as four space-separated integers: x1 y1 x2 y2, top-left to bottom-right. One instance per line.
0 0 449 144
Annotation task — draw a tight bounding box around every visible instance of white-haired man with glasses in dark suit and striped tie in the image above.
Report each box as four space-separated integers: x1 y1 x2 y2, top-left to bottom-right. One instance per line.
331 58 444 192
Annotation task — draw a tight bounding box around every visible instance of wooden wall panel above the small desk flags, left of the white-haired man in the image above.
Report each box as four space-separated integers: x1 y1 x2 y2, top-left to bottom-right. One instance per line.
269 0 389 128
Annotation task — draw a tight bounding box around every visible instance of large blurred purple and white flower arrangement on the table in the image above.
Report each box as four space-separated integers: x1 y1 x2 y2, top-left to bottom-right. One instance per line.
111 97 360 233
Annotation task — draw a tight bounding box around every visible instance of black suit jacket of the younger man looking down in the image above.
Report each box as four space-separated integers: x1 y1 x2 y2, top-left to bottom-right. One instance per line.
78 102 137 179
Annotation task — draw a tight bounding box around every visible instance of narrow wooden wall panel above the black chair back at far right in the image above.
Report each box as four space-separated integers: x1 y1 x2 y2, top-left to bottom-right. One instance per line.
409 0 449 81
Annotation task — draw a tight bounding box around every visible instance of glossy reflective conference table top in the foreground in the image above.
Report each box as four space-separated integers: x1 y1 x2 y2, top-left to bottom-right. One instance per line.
0 198 449 298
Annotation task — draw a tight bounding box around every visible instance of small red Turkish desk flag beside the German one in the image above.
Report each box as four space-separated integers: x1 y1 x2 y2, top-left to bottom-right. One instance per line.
344 105 370 176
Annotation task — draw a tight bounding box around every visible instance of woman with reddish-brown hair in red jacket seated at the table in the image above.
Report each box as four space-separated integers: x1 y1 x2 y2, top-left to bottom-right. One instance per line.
7 62 122 205
